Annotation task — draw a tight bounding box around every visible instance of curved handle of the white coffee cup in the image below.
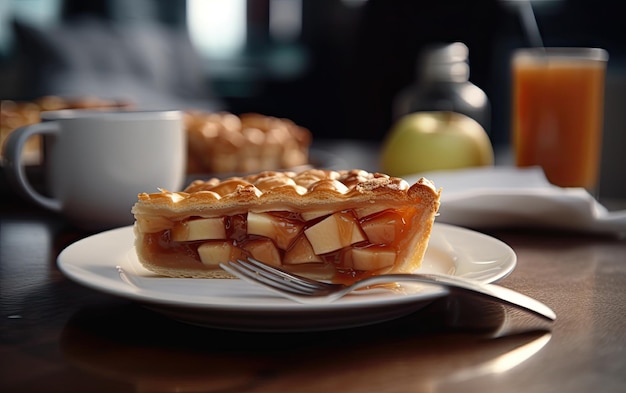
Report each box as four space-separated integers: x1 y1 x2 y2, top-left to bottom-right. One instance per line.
4 121 62 212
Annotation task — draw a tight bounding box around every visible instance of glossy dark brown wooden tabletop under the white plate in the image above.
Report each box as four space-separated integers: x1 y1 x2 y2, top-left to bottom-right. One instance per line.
0 141 626 393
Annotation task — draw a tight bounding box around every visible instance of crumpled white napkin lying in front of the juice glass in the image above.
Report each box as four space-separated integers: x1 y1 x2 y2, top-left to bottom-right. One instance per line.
406 166 626 234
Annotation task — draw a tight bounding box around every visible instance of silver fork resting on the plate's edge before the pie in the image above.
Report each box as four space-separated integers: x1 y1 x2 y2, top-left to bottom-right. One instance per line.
220 258 556 321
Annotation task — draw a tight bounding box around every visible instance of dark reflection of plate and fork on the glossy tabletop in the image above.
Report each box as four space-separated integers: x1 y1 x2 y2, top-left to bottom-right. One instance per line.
60 298 550 392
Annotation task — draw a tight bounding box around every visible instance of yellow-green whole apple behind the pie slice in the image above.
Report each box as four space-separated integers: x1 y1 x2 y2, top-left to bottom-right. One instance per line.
380 111 493 177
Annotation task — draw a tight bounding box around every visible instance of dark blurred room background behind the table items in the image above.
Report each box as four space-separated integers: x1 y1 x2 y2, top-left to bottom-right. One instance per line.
0 0 626 147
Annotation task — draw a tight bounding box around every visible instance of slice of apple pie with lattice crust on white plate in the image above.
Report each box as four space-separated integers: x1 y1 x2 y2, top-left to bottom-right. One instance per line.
133 169 440 282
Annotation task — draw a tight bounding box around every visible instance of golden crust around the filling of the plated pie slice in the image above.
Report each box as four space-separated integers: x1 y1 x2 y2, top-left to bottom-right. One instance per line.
132 169 441 278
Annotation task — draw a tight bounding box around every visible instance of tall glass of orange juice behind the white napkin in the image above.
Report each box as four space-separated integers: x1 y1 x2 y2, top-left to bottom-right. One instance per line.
511 48 608 194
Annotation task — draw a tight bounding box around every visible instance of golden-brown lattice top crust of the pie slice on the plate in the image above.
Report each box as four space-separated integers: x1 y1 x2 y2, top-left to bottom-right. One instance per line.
133 169 439 227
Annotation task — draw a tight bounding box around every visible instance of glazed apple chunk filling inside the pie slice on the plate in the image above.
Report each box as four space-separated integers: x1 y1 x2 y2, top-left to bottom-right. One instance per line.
154 208 413 278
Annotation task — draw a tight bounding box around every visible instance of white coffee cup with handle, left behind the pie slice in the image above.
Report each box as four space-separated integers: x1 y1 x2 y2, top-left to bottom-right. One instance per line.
4 110 187 231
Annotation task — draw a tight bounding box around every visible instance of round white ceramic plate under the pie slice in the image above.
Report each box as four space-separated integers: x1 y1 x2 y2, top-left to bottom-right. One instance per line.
58 224 517 331
